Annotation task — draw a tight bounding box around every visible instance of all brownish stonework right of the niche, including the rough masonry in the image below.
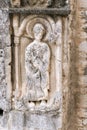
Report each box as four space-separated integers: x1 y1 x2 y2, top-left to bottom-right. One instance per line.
63 0 87 130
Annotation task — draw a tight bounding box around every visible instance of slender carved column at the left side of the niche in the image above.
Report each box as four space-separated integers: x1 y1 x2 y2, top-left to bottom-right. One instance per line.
13 15 20 98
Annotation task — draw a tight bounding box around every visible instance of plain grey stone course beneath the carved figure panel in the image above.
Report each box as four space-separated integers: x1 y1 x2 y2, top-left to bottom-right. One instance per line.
7 110 62 130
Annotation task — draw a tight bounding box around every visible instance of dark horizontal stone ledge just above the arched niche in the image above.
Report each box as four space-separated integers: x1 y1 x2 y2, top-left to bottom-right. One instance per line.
9 6 70 16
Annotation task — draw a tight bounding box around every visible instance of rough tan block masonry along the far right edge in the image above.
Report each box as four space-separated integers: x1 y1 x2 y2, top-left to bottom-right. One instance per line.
76 0 87 130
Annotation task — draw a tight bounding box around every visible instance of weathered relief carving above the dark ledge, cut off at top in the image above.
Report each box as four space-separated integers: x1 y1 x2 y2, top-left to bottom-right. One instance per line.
10 0 66 8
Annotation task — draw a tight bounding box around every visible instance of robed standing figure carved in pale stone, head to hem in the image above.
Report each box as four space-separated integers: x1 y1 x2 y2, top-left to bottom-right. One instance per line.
25 23 50 101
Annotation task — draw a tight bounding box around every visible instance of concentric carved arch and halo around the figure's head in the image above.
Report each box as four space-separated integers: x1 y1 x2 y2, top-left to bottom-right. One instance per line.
18 15 55 41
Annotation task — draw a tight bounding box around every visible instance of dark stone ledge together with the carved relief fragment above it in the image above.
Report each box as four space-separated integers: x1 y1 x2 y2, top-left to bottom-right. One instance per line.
9 0 70 16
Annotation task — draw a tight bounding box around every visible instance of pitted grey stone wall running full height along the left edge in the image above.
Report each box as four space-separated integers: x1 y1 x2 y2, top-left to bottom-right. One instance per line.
0 0 11 130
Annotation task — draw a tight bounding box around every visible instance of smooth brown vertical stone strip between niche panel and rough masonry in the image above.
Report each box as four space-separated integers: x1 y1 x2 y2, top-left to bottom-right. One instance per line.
63 0 77 130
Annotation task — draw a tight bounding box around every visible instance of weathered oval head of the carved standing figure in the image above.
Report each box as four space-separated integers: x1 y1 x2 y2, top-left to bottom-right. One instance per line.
33 23 45 40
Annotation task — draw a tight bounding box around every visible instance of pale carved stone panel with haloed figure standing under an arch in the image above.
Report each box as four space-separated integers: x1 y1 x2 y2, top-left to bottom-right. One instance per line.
13 15 62 112
